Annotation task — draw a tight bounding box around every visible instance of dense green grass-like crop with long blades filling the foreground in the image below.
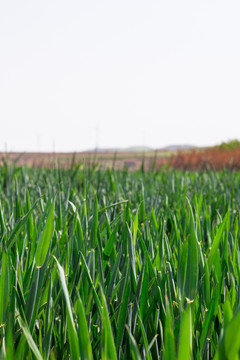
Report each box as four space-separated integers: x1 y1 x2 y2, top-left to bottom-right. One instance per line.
0 163 240 360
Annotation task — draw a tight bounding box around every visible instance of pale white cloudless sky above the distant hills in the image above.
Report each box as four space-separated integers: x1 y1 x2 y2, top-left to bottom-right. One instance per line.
0 0 240 151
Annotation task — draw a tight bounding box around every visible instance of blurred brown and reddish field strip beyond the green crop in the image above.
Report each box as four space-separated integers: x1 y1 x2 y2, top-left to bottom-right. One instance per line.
0 148 240 171
